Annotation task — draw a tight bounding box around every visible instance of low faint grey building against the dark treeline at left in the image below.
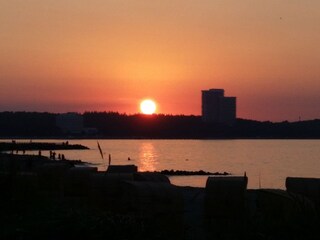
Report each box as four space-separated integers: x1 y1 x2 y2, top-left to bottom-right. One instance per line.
56 113 83 134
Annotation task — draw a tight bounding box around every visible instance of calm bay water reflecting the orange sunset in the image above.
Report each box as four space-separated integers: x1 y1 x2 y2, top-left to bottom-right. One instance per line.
6 140 320 189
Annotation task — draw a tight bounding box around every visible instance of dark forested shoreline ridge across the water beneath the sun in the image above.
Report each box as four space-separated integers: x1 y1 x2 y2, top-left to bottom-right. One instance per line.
0 112 320 139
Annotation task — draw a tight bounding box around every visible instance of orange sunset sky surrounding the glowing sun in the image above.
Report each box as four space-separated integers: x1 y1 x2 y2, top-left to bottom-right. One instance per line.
0 0 320 121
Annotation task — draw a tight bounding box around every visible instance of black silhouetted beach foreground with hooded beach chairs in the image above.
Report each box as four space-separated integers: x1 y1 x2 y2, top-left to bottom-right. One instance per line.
0 154 320 240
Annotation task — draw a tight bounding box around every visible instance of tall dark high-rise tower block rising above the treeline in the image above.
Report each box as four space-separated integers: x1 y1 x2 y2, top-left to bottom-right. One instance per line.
202 89 236 125
